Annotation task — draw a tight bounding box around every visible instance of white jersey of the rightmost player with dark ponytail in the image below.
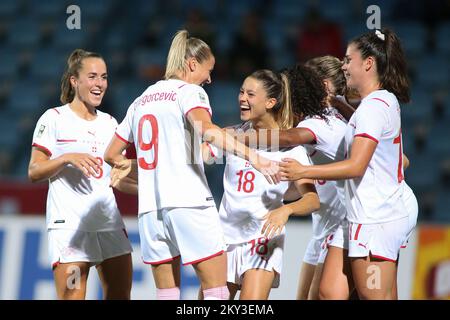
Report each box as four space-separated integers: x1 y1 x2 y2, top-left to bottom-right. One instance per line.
345 90 408 224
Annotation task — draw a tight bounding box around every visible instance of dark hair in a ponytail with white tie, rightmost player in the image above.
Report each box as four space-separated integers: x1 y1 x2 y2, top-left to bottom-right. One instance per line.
350 28 410 103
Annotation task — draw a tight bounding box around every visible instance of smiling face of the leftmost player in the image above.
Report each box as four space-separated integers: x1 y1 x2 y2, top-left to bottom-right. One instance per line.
71 58 108 107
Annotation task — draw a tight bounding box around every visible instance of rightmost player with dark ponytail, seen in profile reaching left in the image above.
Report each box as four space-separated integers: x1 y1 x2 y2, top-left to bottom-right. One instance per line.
280 29 411 299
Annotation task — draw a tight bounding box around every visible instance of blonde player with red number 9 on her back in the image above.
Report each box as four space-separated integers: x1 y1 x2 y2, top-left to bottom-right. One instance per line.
105 30 277 299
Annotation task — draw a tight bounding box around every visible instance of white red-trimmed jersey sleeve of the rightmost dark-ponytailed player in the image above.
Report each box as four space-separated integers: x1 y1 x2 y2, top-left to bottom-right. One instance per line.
355 99 389 143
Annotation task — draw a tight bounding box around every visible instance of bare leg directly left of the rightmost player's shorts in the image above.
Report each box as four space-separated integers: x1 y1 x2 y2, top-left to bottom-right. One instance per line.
319 246 353 300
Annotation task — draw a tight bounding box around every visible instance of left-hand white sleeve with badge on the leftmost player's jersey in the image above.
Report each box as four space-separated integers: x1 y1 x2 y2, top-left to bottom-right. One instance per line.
32 109 59 157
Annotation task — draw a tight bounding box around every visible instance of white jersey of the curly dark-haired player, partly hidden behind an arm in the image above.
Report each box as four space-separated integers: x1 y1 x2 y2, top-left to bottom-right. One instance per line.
297 108 347 239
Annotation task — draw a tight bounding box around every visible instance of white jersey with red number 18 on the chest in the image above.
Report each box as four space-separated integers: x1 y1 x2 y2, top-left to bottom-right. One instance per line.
219 122 311 244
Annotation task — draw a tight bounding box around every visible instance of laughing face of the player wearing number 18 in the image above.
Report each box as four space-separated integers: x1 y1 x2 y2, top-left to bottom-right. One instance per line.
239 77 274 121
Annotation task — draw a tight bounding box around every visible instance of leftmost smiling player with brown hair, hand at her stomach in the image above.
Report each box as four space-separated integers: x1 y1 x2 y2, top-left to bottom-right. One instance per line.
28 49 132 299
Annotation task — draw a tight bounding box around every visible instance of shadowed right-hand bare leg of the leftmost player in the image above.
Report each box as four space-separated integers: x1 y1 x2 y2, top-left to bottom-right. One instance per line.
97 253 133 300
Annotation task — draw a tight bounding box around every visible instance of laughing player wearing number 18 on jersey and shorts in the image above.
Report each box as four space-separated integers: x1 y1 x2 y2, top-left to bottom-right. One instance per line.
214 70 321 300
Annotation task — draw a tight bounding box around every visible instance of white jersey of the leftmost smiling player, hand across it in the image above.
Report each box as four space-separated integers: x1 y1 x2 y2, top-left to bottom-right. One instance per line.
33 104 125 232
